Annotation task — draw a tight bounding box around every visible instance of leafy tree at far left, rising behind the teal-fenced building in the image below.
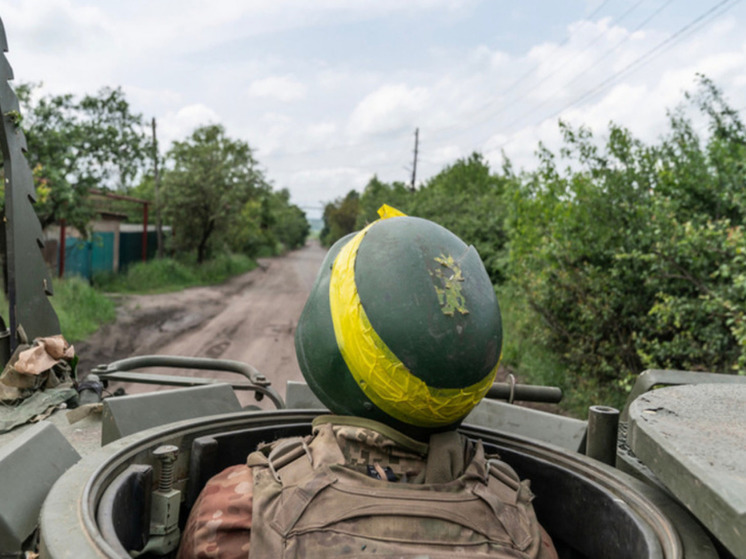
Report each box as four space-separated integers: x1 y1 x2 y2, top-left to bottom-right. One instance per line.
17 84 150 232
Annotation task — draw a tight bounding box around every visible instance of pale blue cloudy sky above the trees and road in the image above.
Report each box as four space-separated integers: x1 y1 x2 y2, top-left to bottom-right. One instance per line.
0 0 746 217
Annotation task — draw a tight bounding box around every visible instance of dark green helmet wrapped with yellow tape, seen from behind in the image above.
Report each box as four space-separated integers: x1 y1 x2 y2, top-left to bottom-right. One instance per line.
295 206 502 437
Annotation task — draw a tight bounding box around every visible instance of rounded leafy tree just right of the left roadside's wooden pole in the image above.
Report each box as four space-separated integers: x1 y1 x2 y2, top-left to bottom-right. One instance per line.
163 125 269 263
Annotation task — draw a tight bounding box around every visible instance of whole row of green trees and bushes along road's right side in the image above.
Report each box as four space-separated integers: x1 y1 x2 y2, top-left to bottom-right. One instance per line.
321 77 746 412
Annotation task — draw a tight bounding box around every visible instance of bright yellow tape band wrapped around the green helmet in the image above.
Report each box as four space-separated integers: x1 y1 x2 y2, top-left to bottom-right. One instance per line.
329 221 497 427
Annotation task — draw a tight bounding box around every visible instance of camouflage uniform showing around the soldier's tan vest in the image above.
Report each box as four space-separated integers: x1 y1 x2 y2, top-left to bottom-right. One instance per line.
178 416 557 559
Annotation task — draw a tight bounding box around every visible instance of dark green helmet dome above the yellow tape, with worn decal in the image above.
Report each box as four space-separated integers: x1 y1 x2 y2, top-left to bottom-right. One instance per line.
355 217 502 388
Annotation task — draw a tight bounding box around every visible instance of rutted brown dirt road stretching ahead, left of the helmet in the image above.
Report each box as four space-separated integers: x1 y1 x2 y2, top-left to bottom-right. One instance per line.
76 243 325 407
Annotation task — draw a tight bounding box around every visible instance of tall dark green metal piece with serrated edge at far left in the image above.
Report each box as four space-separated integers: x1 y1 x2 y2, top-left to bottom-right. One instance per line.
0 22 60 351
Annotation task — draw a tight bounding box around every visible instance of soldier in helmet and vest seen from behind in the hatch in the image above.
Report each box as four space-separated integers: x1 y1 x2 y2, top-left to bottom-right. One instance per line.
178 206 557 559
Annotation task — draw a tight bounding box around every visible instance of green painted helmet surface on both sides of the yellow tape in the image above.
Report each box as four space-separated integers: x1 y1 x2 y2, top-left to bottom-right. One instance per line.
295 217 502 438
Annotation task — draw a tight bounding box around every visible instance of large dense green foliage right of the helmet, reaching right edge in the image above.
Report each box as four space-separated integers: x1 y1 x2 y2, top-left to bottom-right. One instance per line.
508 79 746 404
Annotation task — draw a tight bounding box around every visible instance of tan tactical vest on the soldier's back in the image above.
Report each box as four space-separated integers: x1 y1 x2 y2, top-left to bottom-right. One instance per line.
247 424 541 559
